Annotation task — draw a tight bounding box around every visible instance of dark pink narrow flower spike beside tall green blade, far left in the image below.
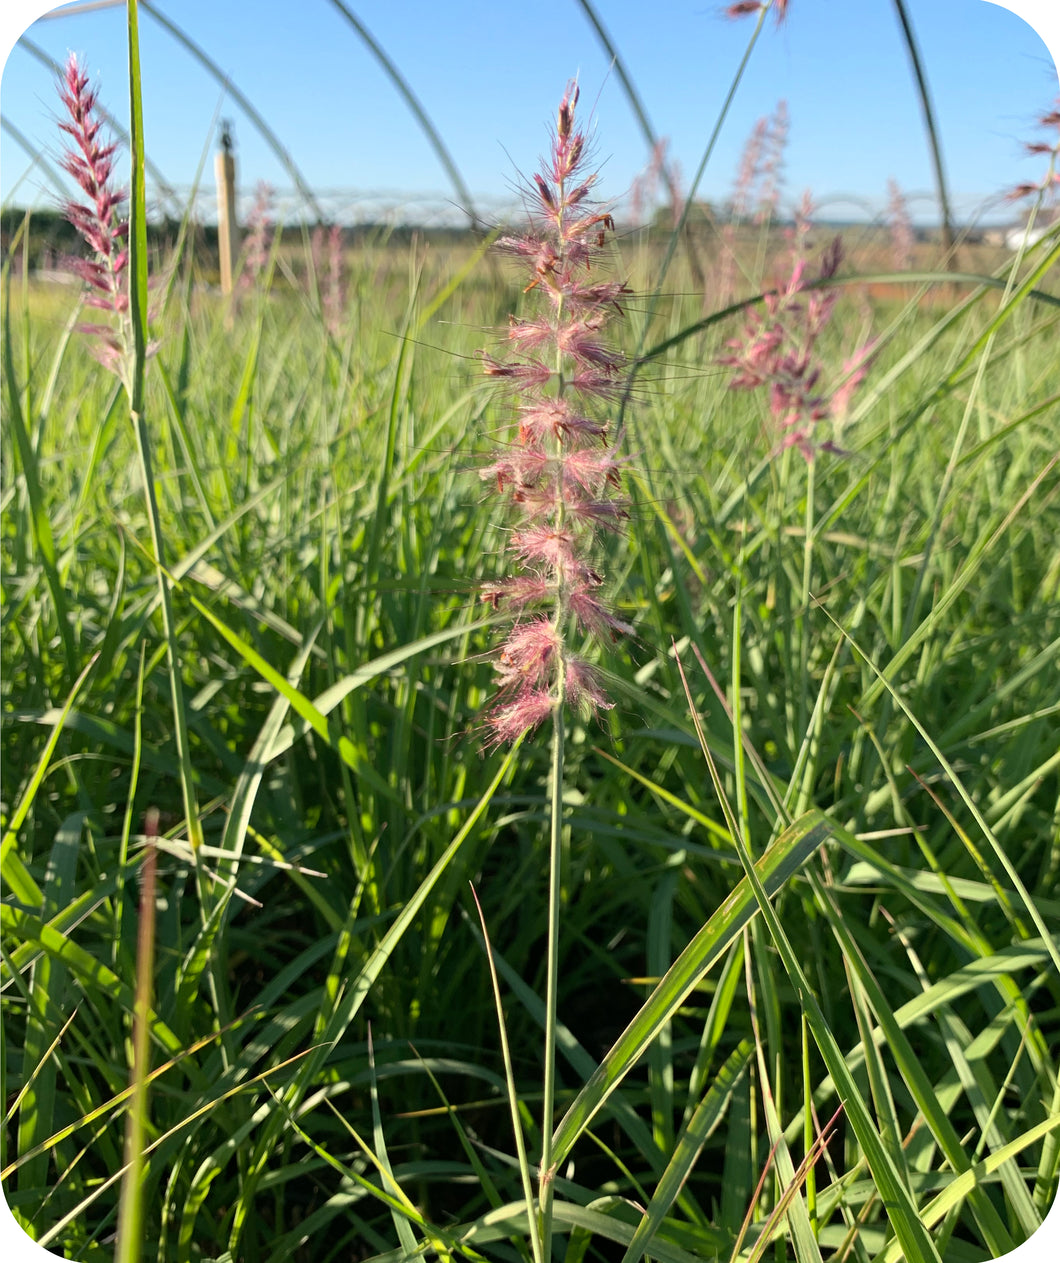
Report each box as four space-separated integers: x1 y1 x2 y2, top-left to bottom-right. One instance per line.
58 53 129 375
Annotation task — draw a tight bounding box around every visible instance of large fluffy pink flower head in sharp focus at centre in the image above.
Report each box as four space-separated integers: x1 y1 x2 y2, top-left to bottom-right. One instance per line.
480 82 632 745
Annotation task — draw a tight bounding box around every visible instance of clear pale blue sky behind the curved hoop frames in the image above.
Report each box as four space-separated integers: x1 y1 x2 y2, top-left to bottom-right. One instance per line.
0 0 1060 221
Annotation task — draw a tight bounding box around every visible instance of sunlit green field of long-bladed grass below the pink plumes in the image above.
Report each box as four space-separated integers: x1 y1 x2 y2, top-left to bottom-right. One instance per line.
0 4 1060 1263
